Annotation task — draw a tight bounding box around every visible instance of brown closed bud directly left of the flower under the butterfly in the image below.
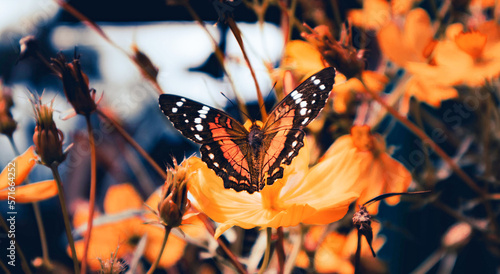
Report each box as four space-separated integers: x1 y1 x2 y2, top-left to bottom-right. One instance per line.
158 160 189 227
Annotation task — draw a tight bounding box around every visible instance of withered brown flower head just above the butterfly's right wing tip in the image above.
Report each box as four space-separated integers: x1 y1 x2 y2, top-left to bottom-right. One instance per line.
302 25 365 79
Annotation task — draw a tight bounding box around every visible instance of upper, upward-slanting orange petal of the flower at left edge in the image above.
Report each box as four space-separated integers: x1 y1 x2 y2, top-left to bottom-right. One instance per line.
0 146 37 189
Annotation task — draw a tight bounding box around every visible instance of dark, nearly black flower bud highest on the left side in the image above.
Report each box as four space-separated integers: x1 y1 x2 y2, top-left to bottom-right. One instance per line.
51 53 97 116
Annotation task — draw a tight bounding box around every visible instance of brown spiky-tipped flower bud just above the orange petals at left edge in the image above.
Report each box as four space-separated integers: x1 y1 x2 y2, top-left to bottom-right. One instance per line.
31 94 66 167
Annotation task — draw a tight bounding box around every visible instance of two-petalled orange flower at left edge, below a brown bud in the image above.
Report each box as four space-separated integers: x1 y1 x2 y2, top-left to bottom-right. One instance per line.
0 146 57 203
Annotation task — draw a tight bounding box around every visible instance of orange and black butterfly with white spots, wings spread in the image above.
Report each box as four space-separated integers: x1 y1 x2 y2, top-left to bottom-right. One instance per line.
159 67 335 194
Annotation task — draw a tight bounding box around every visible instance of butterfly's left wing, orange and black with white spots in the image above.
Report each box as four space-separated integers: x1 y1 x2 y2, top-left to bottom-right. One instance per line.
159 94 257 193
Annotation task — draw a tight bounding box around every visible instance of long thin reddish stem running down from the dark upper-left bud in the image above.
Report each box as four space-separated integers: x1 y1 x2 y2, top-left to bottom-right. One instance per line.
81 115 97 274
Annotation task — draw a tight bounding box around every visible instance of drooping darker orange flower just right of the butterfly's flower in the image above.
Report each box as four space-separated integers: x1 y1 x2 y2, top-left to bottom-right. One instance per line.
324 126 411 214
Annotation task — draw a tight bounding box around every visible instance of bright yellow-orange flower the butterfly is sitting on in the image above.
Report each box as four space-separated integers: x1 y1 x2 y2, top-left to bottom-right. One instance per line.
187 138 366 238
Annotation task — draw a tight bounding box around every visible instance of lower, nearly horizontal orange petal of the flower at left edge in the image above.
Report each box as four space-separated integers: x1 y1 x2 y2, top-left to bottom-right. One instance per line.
0 180 57 203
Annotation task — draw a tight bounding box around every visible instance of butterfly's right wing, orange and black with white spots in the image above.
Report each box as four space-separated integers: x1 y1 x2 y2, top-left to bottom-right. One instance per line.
261 67 335 185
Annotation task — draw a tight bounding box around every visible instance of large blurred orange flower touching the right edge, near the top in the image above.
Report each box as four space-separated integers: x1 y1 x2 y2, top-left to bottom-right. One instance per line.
406 22 500 111
